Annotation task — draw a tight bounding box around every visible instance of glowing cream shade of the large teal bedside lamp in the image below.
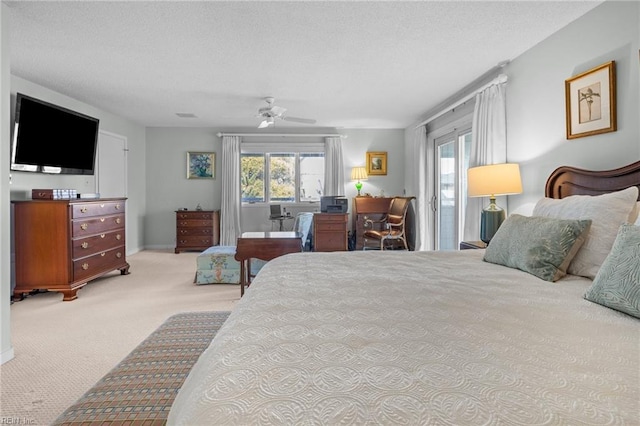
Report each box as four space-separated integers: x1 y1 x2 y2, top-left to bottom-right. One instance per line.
467 163 522 197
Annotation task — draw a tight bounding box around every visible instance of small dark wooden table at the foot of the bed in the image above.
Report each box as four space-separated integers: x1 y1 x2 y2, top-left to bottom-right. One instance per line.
235 232 302 297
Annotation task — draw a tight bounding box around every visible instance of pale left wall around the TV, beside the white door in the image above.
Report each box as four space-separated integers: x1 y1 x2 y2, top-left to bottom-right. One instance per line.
7 76 146 254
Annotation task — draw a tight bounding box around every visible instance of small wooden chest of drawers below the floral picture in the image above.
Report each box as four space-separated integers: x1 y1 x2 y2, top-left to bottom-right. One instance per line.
175 210 220 253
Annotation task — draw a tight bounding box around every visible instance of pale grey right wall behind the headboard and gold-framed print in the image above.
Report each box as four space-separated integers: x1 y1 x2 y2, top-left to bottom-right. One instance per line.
404 1 640 231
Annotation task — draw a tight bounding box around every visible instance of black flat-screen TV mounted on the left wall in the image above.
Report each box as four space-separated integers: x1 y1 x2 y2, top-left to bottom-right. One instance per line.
11 93 99 175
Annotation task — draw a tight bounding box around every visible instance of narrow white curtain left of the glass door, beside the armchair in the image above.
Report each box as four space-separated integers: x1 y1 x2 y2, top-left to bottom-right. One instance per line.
413 126 434 250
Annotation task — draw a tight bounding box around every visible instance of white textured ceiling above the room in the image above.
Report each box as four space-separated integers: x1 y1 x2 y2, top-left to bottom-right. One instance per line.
5 1 601 128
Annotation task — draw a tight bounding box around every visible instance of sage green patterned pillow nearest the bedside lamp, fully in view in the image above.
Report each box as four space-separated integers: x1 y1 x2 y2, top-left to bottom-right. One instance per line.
484 214 591 281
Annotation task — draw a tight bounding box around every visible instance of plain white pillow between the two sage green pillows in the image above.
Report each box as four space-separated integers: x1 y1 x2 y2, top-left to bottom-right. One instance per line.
533 186 638 279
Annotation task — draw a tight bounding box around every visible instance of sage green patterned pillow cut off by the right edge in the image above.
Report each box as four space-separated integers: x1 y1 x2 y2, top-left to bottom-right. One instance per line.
584 225 640 318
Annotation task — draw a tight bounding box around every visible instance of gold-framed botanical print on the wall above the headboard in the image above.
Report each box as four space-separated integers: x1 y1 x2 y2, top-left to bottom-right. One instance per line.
564 61 617 139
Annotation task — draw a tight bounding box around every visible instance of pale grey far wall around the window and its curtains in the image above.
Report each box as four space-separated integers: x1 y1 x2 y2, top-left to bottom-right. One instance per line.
144 127 404 246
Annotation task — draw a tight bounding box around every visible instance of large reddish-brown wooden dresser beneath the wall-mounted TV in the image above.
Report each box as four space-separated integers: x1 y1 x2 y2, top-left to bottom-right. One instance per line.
13 198 129 301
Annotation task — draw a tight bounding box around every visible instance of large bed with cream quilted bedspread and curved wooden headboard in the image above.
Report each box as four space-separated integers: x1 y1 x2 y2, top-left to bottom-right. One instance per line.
168 162 640 425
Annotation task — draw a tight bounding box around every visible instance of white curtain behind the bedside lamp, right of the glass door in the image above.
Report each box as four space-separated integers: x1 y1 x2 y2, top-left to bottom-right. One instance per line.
463 78 507 241
